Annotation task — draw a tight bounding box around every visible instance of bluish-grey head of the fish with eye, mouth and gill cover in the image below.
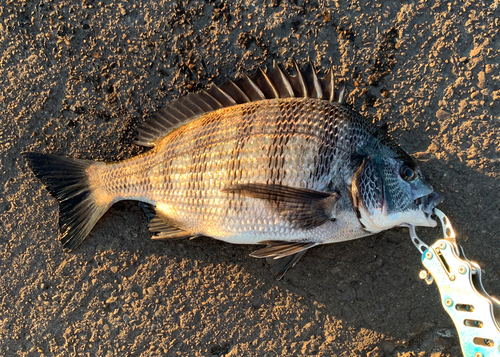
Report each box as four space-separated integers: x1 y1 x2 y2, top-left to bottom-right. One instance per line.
351 155 442 233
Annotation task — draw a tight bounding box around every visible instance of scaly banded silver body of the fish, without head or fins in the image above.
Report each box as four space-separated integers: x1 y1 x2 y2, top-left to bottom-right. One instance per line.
94 98 369 244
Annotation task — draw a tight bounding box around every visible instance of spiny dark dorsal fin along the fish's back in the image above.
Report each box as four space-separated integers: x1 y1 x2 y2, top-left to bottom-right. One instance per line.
135 59 345 147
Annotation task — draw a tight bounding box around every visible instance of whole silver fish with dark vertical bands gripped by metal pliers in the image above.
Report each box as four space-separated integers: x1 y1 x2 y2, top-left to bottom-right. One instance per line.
23 59 442 279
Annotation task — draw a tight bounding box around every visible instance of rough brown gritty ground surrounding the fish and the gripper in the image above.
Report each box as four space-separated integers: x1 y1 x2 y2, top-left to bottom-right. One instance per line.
0 0 500 357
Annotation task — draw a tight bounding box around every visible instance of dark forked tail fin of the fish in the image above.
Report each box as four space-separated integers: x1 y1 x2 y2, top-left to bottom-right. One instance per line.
23 152 111 250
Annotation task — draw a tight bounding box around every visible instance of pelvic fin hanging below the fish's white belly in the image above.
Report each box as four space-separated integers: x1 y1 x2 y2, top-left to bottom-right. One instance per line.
250 240 317 280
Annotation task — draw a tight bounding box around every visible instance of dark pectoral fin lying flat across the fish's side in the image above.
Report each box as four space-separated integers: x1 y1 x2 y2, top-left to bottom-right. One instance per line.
222 183 340 229
